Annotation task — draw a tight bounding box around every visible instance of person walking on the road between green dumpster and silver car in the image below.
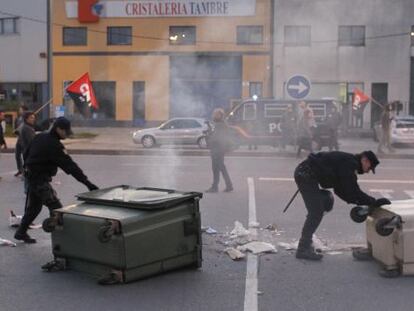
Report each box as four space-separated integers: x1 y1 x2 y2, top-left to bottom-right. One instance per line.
206 109 233 192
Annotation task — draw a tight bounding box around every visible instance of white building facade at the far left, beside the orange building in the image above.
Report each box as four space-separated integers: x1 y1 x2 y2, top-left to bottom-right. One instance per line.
0 0 47 109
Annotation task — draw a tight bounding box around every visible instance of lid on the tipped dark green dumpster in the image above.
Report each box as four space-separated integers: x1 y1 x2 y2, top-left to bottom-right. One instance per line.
76 185 202 209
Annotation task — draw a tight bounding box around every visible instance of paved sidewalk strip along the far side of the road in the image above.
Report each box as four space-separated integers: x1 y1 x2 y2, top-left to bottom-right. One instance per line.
3 127 414 159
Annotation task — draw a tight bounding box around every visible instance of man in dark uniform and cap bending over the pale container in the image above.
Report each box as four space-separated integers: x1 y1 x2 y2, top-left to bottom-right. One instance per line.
294 151 391 260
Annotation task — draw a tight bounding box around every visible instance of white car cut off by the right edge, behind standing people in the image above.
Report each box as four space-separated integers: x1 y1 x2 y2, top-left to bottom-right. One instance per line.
373 116 414 144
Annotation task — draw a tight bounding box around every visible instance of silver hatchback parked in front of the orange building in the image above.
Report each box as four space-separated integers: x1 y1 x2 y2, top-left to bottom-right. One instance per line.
132 118 208 148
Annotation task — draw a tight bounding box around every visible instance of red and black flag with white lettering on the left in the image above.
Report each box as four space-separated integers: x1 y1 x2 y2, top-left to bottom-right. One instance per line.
66 73 99 115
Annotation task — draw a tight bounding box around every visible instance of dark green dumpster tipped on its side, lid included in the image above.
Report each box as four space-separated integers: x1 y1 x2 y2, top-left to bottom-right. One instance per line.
42 185 202 284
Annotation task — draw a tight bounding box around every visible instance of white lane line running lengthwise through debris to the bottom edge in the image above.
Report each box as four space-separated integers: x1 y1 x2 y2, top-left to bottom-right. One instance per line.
243 177 258 311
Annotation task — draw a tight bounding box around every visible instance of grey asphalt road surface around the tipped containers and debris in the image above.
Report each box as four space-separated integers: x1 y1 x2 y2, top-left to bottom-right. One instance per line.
0 154 414 311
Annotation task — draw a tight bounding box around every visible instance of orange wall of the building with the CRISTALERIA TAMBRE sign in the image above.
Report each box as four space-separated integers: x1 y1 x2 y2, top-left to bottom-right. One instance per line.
52 0 271 121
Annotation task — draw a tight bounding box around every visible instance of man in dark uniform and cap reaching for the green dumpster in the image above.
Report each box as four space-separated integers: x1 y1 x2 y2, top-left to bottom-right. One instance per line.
14 117 98 243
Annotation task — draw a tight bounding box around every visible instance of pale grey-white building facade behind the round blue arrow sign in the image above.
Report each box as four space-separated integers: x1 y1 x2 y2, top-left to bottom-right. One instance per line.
273 0 414 128
